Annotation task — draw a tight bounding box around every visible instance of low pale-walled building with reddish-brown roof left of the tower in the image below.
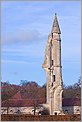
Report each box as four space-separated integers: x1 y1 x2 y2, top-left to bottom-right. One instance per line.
1 91 44 114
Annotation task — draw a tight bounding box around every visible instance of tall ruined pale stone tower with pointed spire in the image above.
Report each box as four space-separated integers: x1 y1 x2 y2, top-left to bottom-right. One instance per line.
42 14 62 115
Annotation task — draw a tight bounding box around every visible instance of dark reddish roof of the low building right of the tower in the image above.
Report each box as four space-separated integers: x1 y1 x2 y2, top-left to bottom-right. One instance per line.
62 98 81 106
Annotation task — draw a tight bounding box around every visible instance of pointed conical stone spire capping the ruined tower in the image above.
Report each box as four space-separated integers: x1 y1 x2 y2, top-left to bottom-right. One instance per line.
52 13 61 34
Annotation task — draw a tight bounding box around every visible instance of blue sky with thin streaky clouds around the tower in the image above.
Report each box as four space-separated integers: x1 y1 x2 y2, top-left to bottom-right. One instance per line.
1 1 81 85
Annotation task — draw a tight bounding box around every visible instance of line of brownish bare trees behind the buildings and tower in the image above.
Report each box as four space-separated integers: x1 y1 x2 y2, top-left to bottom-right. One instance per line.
1 79 81 102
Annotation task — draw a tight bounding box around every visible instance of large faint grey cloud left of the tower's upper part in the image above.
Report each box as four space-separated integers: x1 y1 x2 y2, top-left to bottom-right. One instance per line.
2 30 44 44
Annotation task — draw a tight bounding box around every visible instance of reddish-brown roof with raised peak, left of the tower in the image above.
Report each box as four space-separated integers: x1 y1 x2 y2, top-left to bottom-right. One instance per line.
1 91 45 107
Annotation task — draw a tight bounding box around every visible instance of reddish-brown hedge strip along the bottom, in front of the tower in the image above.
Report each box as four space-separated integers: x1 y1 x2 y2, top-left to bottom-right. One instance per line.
1 114 81 121
